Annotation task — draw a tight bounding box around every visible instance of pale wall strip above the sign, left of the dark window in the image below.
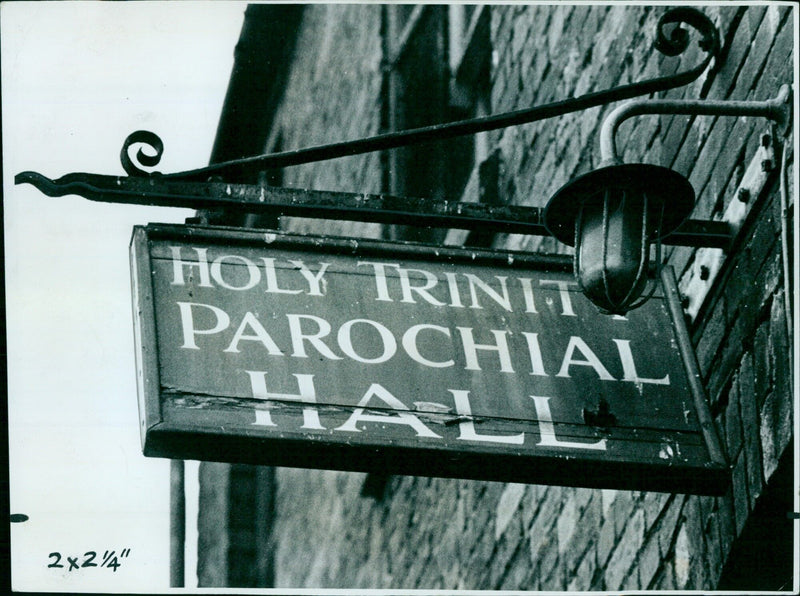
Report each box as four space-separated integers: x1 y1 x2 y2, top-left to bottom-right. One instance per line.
267 5 383 238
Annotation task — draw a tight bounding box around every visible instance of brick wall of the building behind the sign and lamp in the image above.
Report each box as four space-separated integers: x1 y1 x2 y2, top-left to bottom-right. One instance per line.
197 5 793 591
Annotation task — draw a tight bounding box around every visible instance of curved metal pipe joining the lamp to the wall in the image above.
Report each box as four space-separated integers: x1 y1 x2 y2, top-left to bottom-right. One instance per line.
600 85 791 164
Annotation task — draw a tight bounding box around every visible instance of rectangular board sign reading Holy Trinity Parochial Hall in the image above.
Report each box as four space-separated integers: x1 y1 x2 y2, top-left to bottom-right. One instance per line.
131 225 728 494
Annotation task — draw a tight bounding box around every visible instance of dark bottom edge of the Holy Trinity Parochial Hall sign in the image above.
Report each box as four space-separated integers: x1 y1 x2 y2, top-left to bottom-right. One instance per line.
145 424 728 496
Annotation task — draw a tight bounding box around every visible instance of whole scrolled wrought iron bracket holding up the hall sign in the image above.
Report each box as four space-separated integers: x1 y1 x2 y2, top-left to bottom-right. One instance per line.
15 6 732 248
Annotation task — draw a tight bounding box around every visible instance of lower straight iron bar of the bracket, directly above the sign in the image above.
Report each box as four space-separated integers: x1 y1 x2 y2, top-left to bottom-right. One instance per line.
15 172 732 248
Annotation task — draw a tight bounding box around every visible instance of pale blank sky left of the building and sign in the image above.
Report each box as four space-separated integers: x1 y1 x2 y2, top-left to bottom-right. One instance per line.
0 1 245 592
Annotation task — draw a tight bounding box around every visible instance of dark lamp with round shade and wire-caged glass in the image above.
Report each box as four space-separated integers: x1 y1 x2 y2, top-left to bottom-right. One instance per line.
544 164 695 314
